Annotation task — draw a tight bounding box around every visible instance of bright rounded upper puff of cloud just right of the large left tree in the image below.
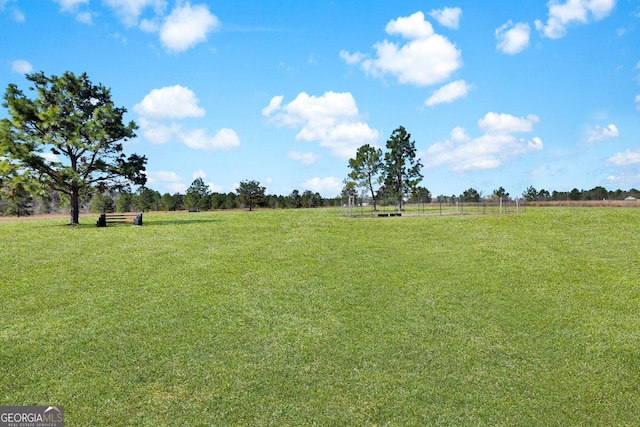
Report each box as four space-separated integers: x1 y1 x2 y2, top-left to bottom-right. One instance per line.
133 85 204 120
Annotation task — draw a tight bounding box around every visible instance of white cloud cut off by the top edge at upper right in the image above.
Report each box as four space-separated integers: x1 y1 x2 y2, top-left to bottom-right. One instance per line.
535 0 616 39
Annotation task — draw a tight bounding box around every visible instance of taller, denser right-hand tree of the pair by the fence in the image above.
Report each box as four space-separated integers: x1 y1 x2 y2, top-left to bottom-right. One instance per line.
384 126 422 210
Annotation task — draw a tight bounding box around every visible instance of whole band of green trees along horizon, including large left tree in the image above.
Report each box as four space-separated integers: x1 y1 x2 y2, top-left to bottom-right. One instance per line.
0 72 640 221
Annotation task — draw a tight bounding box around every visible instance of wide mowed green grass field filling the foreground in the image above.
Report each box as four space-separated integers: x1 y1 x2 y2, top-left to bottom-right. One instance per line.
0 208 640 426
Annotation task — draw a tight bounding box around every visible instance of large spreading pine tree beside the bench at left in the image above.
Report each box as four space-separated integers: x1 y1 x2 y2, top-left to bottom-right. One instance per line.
0 72 147 224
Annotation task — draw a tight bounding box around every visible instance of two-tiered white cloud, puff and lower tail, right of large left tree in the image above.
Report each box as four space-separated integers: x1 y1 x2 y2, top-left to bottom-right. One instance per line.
133 85 240 150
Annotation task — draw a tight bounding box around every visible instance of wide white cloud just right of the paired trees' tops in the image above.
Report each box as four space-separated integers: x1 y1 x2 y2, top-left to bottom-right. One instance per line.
421 113 544 172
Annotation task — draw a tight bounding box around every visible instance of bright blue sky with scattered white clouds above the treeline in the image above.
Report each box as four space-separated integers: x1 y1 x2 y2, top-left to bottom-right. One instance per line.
0 0 640 197
